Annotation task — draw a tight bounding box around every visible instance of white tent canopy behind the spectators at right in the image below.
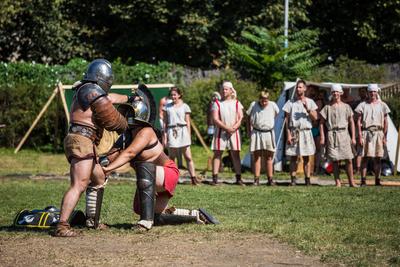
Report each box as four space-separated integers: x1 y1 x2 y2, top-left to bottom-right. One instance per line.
244 82 400 171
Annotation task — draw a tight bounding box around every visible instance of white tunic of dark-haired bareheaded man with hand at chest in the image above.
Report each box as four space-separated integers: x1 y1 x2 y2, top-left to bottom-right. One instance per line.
282 97 318 156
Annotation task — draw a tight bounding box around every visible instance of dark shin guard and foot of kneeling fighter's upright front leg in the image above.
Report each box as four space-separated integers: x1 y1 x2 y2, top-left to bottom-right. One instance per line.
135 162 156 230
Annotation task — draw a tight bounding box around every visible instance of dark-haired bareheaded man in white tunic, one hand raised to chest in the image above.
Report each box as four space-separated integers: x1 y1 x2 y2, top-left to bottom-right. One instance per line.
282 80 318 186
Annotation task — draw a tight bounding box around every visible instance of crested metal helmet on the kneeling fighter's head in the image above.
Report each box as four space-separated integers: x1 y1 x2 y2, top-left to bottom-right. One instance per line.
118 84 156 127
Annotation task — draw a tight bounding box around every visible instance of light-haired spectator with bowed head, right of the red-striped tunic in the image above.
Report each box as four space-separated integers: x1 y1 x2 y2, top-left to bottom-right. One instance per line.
246 91 279 186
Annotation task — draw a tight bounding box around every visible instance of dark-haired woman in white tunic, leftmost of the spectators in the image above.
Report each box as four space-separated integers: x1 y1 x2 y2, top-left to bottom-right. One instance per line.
164 87 199 185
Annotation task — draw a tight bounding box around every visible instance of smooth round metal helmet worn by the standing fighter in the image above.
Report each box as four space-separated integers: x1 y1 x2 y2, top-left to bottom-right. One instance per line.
83 59 114 93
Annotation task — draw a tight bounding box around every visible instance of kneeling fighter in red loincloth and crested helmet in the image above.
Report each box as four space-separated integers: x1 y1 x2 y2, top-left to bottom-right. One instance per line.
100 85 218 230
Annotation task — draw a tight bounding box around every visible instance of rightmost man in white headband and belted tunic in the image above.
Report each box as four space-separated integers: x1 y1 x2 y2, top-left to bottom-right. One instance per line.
355 83 390 186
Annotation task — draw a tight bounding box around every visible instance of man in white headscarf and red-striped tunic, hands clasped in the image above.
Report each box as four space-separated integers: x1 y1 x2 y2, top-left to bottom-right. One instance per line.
211 81 244 185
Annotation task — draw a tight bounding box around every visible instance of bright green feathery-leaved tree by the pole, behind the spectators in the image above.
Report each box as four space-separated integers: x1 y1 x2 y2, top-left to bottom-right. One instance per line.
224 26 321 89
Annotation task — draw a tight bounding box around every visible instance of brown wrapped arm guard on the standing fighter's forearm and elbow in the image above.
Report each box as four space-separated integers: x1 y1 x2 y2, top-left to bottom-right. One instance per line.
90 96 128 134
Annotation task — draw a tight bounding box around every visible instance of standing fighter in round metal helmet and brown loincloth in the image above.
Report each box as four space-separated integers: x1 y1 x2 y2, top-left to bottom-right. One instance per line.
55 59 129 237
